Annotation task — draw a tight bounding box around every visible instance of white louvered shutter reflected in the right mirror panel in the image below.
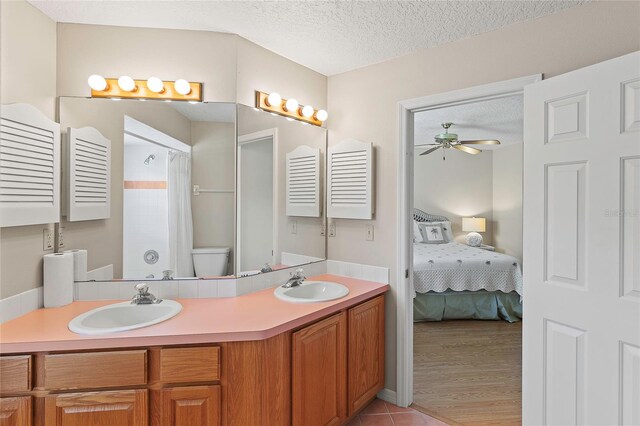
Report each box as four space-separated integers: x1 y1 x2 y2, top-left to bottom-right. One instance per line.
286 145 321 217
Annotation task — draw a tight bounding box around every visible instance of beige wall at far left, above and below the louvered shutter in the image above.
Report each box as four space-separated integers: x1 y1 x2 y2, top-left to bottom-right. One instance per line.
0 1 56 298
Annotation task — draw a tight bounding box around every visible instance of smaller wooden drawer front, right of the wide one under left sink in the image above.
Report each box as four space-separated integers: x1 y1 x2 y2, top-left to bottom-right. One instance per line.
151 346 220 383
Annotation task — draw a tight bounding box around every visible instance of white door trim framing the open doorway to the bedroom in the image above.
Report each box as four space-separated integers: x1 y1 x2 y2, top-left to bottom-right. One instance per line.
396 74 542 407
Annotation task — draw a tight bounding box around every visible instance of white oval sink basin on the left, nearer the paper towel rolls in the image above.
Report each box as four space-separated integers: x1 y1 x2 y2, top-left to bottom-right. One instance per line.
69 300 182 335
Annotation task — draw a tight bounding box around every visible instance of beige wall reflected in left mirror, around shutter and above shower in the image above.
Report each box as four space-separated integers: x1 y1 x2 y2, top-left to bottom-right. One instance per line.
60 98 191 278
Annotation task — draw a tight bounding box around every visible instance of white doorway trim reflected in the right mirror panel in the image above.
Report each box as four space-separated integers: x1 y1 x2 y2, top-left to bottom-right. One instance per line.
235 127 278 275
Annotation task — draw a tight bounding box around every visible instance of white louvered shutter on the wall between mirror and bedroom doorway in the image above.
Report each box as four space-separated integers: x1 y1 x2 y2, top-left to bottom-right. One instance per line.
327 139 374 219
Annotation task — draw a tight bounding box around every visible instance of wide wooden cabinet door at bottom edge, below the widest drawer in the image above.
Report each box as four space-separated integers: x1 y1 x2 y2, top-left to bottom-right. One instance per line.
44 390 148 426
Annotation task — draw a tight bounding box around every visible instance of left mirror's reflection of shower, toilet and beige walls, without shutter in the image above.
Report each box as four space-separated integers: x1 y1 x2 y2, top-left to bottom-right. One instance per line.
60 97 236 280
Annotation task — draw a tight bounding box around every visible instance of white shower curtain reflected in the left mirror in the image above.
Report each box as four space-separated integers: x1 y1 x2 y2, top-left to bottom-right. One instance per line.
168 151 194 277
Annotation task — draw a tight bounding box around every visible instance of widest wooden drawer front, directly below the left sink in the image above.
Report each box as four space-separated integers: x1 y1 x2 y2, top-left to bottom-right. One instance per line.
43 350 147 390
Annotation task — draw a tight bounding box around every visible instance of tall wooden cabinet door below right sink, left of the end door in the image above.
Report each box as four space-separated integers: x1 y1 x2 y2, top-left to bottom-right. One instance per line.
292 312 347 426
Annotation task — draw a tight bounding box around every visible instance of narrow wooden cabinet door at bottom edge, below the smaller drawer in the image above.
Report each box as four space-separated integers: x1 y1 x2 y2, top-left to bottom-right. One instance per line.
151 386 220 426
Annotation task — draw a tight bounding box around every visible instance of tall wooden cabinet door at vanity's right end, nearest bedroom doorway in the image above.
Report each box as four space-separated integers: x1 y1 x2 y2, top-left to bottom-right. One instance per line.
348 296 384 416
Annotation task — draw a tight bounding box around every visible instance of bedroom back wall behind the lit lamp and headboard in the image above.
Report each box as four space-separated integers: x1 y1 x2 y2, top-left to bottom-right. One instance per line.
413 149 495 244
